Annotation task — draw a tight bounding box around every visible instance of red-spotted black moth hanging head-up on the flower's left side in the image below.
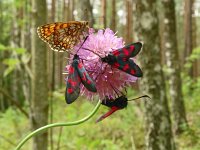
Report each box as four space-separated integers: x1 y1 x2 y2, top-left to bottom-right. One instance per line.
65 54 97 104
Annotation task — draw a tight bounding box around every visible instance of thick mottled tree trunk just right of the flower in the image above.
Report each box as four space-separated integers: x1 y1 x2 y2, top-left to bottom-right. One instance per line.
135 0 175 150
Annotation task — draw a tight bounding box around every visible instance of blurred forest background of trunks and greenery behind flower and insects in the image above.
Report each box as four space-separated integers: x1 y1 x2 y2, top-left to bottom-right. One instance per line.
0 0 200 150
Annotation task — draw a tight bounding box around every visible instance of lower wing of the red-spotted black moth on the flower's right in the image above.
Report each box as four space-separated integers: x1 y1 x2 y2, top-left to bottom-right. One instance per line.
111 59 143 77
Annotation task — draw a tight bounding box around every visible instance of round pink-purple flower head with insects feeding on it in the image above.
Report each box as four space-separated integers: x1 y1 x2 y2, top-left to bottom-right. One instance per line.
66 28 137 99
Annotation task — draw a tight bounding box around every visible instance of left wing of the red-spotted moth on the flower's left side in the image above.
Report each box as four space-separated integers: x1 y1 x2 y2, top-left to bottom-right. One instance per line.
65 62 81 104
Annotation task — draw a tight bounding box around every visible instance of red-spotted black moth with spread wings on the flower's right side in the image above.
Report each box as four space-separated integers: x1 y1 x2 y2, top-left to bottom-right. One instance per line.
101 42 143 77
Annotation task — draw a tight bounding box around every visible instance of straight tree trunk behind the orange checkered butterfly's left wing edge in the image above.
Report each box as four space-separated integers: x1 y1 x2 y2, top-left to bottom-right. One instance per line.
31 0 48 150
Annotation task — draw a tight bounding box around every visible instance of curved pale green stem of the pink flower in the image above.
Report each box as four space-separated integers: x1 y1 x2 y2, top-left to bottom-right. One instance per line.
15 100 101 150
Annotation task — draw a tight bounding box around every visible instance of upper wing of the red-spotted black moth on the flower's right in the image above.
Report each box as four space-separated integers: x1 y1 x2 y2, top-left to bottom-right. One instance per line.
111 42 142 60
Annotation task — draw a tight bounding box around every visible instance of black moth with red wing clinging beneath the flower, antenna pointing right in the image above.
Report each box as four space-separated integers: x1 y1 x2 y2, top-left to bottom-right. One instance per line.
96 95 150 122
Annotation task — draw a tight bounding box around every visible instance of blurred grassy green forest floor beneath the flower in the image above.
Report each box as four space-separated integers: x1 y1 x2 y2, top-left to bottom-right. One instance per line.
0 85 200 150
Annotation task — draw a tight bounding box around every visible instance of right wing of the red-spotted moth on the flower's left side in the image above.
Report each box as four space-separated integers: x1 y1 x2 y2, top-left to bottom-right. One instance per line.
77 61 97 92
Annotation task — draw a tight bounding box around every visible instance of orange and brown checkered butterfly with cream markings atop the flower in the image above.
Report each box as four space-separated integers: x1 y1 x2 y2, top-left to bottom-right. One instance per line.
37 21 89 52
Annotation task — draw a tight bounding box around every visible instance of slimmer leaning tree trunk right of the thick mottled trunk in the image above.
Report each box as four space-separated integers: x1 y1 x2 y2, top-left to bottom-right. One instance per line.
162 0 187 133
